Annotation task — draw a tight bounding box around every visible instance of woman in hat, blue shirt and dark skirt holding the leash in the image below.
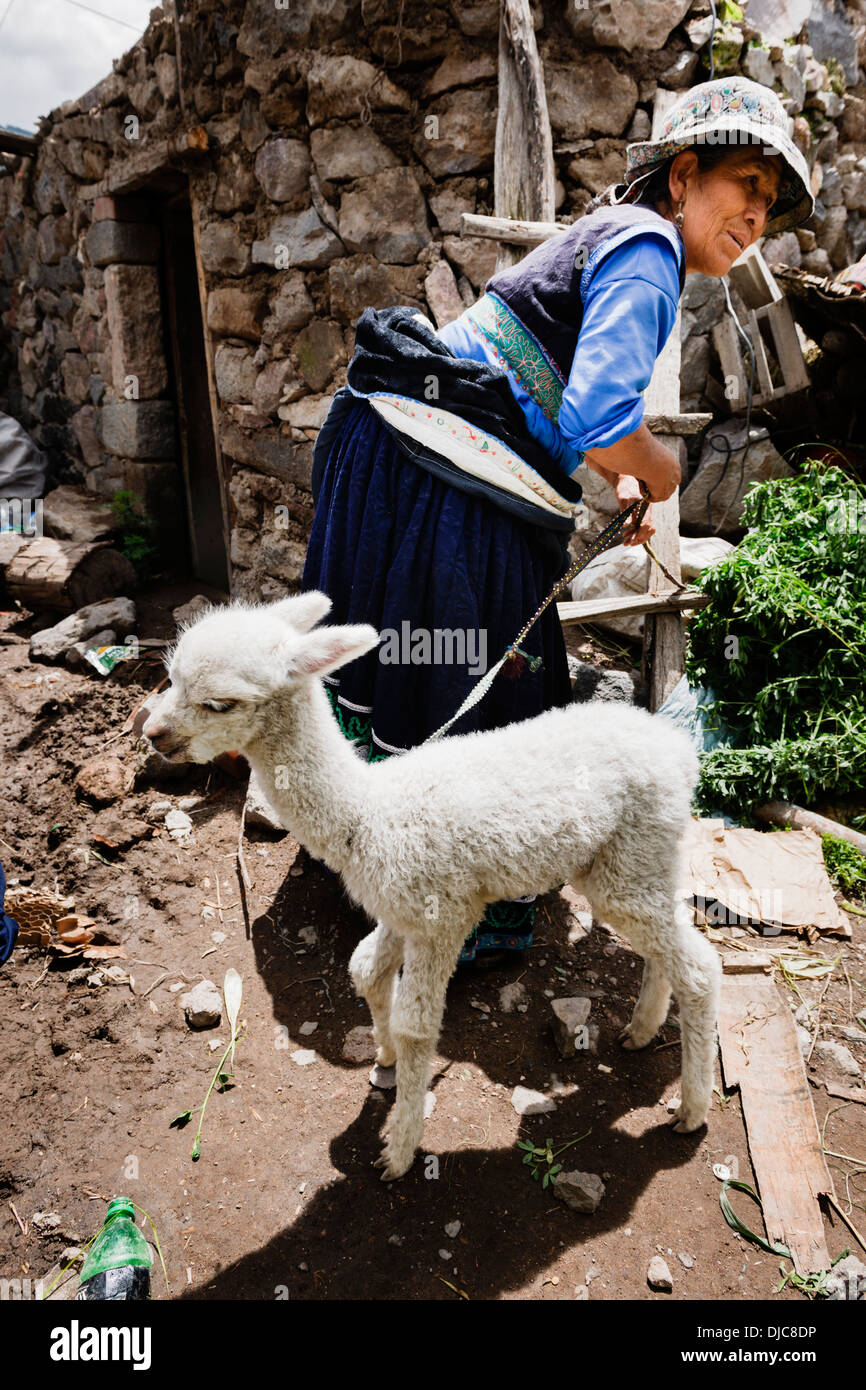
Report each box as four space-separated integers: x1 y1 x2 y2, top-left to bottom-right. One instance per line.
302 78 813 966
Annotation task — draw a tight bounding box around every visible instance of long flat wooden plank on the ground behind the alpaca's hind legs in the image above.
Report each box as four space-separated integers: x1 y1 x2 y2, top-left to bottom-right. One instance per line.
719 974 835 1276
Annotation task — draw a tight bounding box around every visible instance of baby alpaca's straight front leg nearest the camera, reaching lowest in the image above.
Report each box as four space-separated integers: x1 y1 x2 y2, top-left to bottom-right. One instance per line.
377 934 453 1182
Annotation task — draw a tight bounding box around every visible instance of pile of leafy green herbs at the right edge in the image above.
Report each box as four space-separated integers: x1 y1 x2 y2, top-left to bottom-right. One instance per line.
685 460 866 821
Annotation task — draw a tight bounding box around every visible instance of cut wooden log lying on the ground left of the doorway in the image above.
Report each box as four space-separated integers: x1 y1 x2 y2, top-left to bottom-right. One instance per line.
3 537 138 613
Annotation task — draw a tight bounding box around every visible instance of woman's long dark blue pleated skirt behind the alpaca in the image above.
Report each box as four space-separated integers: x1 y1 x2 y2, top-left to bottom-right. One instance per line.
302 398 571 960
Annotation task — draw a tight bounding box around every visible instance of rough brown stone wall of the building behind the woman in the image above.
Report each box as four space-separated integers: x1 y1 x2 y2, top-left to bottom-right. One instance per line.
0 0 866 596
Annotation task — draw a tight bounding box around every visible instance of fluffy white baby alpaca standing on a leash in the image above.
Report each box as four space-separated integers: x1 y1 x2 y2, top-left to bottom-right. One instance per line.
145 592 721 1179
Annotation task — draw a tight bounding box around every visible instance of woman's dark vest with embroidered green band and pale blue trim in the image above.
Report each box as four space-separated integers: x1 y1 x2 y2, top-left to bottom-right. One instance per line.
475 204 685 423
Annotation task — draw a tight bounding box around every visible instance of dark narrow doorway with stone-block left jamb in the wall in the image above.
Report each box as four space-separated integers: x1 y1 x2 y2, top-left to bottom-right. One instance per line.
95 170 229 591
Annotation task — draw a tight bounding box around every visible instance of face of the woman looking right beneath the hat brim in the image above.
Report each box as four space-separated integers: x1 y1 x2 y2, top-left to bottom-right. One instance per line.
670 150 781 275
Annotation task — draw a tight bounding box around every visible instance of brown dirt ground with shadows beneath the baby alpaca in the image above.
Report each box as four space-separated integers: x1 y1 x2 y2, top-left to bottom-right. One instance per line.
0 587 866 1301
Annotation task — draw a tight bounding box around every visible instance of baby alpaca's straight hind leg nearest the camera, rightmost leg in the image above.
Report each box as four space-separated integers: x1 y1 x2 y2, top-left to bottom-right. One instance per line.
653 904 721 1134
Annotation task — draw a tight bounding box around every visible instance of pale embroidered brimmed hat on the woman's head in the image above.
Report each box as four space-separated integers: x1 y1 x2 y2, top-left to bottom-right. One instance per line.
612 76 815 236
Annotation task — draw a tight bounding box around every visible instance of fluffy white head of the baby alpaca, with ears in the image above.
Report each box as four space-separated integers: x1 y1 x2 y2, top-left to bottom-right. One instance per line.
142 591 379 763
